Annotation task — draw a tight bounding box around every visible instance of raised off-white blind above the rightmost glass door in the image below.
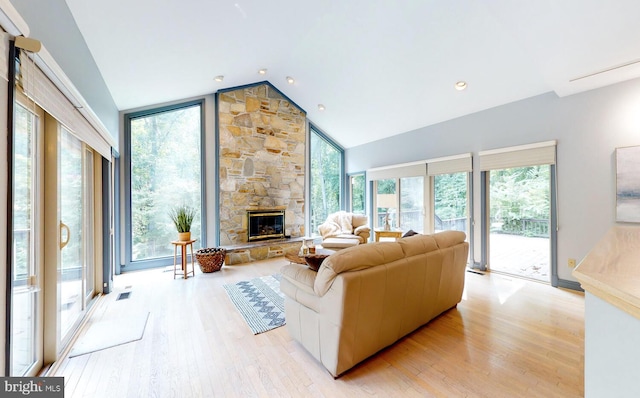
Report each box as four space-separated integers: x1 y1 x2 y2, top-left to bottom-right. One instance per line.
478 140 556 171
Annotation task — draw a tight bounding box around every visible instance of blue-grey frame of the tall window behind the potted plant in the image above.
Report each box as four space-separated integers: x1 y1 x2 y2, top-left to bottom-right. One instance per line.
121 98 207 272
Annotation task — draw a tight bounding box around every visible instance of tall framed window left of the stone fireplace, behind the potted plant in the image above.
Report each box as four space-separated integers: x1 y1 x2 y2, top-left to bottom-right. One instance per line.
124 101 204 270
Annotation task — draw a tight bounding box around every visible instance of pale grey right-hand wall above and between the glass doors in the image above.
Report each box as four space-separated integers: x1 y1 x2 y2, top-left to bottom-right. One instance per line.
346 79 640 281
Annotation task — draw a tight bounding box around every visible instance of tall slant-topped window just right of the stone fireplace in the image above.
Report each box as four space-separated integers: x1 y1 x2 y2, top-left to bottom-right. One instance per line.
306 125 344 236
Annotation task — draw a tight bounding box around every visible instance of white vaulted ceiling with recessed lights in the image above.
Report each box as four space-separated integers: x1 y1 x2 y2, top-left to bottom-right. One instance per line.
66 0 640 148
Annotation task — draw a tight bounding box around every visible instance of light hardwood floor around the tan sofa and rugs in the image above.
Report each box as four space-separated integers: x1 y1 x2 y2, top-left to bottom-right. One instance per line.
50 258 584 398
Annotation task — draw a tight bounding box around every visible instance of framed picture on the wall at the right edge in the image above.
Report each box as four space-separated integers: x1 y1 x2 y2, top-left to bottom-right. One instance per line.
616 146 640 222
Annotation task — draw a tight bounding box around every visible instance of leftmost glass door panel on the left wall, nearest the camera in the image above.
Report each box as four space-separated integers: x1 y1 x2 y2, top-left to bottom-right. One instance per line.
9 103 43 376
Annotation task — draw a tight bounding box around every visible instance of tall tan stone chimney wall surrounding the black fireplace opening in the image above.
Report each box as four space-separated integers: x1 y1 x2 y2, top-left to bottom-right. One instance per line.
218 84 306 246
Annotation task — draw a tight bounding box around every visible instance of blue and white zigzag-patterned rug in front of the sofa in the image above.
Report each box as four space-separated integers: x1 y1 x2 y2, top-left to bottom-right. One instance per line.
224 274 285 334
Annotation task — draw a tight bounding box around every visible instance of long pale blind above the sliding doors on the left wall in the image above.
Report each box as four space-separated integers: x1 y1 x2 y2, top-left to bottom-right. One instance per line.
20 51 111 159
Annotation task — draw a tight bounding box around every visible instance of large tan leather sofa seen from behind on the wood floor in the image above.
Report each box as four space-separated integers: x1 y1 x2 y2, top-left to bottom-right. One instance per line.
280 231 469 377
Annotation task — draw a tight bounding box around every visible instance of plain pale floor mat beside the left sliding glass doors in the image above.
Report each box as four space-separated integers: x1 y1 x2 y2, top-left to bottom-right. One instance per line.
69 312 149 358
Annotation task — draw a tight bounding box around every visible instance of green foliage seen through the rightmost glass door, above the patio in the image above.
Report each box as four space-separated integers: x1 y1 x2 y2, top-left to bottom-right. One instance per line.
489 165 551 237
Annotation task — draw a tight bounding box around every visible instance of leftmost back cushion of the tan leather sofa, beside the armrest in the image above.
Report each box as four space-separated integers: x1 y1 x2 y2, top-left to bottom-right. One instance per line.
313 242 405 296
